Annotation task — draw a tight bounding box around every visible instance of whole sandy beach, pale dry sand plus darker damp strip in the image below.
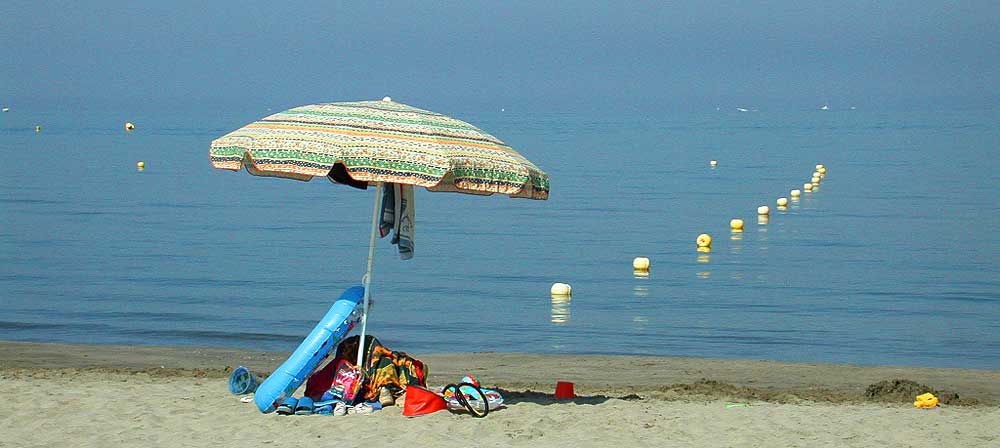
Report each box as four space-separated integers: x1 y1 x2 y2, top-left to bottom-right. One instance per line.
0 342 1000 447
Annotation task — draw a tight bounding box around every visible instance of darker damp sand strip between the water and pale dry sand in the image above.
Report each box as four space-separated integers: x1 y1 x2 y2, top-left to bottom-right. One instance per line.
0 340 1000 405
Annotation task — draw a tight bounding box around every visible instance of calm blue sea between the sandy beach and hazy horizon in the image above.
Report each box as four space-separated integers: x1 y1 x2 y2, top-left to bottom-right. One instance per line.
0 105 1000 369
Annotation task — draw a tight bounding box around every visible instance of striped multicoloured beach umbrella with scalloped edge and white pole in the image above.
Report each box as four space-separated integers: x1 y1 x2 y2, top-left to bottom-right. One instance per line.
209 97 549 365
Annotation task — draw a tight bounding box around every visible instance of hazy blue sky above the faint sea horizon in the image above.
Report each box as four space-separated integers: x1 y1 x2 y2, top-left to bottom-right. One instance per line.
0 0 1000 108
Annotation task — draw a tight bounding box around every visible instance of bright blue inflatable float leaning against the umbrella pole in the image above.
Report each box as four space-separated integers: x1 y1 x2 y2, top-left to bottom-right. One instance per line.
254 286 365 414
